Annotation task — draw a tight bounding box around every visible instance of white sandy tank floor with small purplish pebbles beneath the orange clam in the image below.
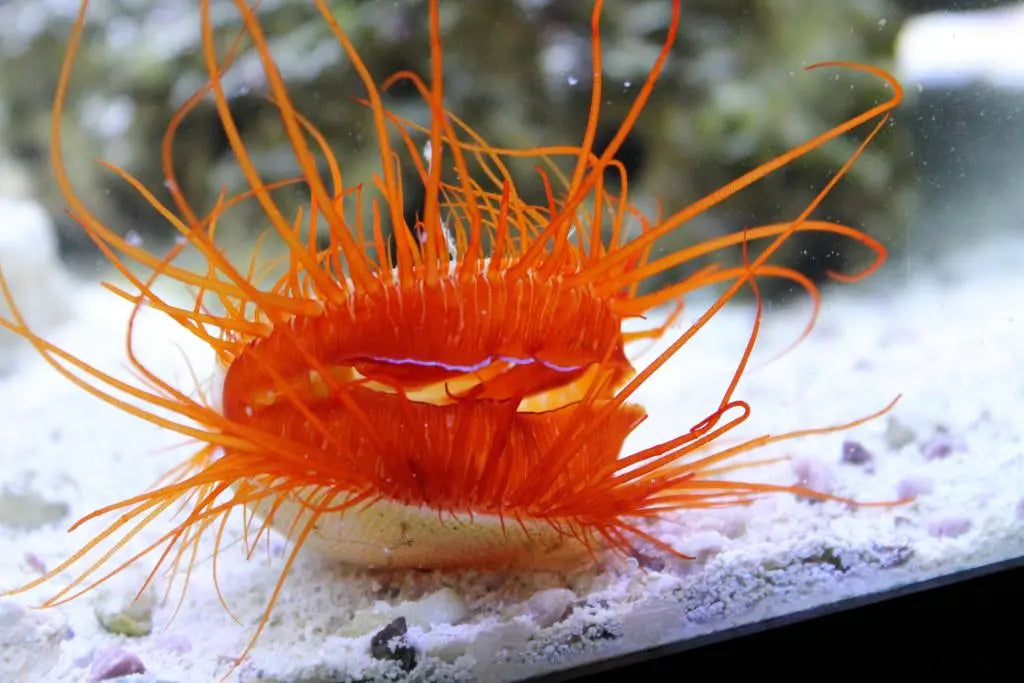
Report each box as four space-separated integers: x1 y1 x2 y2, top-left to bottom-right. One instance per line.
0 228 1024 683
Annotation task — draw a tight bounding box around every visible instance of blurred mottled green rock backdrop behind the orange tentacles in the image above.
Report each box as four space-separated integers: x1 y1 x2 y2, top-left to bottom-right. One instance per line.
0 0 929 296
